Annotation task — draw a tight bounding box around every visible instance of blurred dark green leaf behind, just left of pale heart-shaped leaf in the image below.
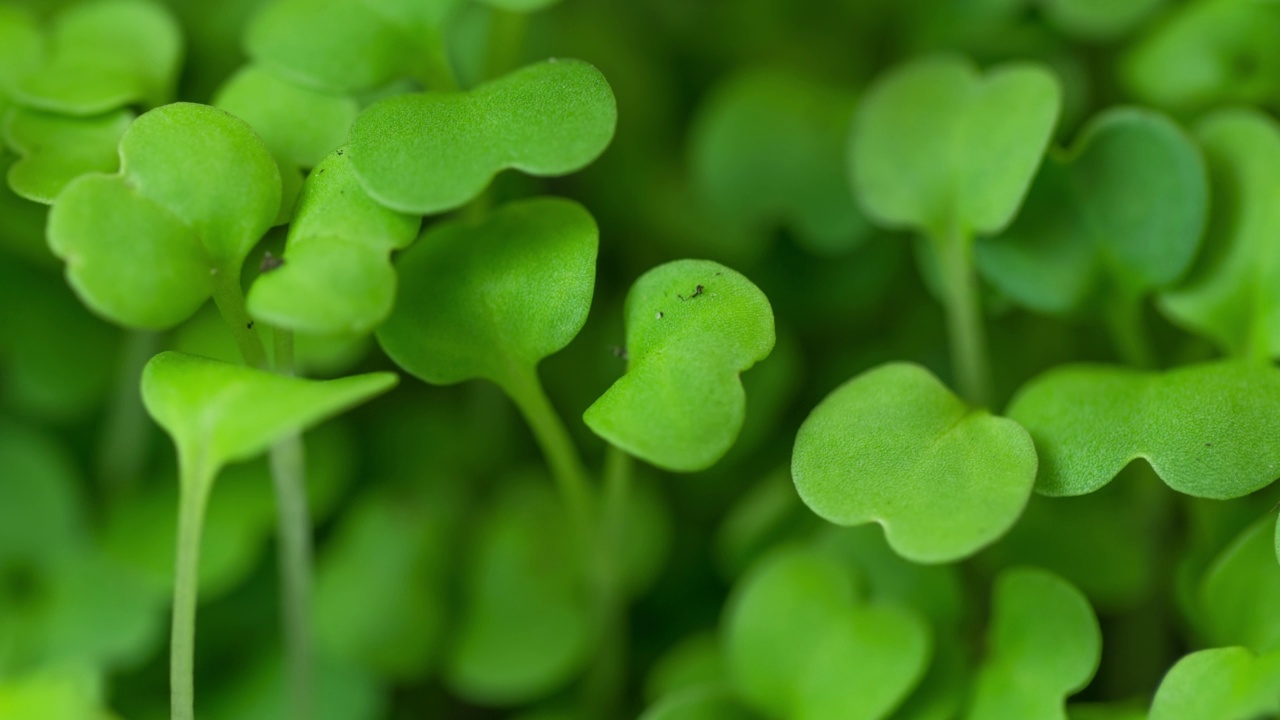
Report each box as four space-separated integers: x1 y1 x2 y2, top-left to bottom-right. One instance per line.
690 69 869 254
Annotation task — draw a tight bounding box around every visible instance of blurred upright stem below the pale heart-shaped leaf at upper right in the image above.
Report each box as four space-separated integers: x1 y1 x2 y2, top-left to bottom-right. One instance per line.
933 228 991 405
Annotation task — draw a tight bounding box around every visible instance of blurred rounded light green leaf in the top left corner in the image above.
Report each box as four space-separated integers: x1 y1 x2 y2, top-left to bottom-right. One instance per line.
10 0 182 115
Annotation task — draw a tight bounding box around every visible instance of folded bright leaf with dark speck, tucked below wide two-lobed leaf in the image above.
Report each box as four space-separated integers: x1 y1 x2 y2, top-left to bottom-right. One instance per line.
247 150 421 334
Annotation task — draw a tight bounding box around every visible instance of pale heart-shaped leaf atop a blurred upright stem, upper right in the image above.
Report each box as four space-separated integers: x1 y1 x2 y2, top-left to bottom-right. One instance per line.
850 56 1061 237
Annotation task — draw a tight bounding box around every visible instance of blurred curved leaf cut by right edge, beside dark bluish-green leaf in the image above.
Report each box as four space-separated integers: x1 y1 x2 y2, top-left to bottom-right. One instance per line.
1160 109 1280 360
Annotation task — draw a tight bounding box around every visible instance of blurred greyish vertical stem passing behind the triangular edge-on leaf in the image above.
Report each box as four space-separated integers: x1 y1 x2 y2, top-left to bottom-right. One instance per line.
262 328 312 720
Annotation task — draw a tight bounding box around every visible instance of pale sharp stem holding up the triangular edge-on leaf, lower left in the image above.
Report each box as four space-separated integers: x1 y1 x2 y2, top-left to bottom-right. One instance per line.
169 453 212 720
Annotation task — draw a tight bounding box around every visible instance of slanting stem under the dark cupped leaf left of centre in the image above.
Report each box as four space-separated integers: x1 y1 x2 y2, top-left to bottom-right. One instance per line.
502 368 594 539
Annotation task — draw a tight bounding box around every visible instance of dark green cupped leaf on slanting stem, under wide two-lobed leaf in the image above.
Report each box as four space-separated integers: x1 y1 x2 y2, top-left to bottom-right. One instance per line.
378 197 599 386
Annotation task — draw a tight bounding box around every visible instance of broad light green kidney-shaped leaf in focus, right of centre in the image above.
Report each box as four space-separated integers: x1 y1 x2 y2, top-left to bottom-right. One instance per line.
791 363 1036 562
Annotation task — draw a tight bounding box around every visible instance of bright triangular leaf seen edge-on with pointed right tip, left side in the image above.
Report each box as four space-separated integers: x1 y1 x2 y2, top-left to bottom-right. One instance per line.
142 352 397 482
